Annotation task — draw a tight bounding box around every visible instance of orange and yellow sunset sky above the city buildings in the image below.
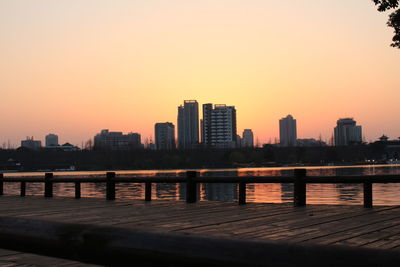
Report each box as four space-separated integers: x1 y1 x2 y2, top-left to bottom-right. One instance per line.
0 0 400 146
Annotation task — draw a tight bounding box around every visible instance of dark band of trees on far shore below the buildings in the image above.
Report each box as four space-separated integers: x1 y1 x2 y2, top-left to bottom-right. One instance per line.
0 142 400 171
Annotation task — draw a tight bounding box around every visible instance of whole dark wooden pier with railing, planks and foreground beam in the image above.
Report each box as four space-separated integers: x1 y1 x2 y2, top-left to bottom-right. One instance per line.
0 169 400 267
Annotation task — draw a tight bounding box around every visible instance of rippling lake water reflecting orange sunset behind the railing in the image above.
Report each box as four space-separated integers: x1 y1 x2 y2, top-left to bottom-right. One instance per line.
4 165 400 205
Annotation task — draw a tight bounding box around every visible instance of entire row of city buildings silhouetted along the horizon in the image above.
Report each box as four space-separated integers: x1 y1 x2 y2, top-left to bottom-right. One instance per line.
13 107 400 150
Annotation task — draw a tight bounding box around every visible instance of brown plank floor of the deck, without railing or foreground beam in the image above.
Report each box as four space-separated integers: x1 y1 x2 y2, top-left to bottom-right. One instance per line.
0 196 400 266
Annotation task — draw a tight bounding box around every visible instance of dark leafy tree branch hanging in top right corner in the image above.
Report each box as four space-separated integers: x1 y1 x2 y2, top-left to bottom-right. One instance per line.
373 0 400 48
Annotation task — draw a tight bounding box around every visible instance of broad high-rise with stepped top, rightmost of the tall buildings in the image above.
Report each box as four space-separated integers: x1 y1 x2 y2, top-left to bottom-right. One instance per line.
334 118 362 146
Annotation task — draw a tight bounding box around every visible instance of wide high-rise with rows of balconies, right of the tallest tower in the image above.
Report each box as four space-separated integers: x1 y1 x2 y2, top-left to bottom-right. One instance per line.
202 104 237 148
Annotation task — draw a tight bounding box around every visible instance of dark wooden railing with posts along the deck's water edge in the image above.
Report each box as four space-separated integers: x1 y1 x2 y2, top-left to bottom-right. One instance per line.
0 169 400 208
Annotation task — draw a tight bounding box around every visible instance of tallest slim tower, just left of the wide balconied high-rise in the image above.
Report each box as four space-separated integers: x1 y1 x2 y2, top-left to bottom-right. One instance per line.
178 100 199 149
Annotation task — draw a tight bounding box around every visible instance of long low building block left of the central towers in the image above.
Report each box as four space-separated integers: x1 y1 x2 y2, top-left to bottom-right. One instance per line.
94 130 143 150
